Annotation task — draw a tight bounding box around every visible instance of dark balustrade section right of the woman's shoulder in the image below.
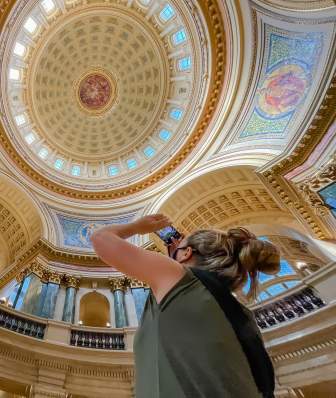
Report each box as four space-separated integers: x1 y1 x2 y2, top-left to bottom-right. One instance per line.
253 287 325 329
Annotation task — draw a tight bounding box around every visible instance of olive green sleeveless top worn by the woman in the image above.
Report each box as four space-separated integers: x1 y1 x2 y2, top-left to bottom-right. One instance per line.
134 269 262 398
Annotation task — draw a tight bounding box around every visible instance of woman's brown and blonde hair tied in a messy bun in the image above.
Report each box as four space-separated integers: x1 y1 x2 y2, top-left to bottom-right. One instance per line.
187 227 280 298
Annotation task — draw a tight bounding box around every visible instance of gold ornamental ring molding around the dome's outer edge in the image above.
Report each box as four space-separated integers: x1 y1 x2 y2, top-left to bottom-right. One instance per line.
0 0 227 200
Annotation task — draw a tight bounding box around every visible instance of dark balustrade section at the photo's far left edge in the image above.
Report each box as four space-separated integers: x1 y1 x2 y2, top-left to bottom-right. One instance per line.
0 309 46 339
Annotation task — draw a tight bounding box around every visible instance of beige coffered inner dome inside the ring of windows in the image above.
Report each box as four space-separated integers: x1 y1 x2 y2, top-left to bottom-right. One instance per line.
26 9 169 162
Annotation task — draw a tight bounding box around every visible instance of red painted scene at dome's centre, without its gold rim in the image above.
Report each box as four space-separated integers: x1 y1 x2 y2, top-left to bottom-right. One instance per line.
79 73 111 109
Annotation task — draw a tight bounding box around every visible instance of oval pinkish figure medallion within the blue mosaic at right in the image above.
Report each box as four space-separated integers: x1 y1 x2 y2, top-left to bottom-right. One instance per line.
258 64 309 118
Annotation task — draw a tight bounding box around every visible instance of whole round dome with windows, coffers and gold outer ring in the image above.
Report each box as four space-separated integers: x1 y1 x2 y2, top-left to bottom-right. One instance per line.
1 0 225 199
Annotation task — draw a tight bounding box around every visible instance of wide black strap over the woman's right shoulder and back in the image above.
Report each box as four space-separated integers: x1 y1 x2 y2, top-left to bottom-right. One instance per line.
190 267 275 398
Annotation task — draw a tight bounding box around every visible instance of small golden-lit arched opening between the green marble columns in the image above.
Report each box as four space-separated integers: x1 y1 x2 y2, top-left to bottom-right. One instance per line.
79 292 110 327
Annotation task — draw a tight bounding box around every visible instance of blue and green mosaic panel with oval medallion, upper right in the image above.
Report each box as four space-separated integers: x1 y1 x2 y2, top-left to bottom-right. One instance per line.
239 25 323 139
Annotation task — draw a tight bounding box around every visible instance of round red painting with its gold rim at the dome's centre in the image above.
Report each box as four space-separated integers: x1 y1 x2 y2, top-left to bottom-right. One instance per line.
75 71 116 115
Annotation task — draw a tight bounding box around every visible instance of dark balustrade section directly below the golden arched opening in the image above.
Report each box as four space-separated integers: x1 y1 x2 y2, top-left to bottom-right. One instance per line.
70 329 125 350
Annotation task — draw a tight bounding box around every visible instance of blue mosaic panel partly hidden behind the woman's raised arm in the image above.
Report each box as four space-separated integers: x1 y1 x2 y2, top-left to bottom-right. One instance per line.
56 213 135 250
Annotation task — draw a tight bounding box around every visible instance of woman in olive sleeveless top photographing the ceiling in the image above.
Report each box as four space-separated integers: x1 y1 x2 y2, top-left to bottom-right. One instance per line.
91 214 279 398
